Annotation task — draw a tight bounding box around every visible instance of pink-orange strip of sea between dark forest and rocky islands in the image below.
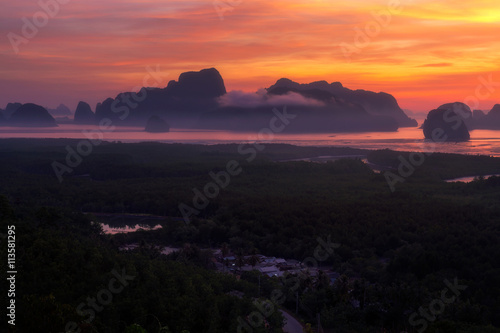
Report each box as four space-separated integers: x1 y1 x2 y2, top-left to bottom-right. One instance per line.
0 124 500 156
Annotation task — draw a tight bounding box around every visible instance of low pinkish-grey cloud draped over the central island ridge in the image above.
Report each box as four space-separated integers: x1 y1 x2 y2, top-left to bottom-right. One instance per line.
219 89 324 107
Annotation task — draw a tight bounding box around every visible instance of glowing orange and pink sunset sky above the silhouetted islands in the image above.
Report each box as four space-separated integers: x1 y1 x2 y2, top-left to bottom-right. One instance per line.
0 0 500 112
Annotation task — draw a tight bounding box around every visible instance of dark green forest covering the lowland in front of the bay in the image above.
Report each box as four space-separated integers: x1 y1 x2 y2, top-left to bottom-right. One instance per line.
0 139 500 333
